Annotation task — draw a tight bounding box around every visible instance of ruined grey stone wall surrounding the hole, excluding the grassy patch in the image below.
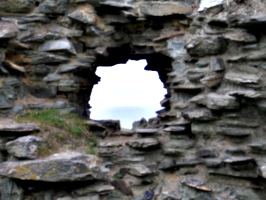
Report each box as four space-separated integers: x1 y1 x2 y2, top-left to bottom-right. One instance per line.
0 0 266 200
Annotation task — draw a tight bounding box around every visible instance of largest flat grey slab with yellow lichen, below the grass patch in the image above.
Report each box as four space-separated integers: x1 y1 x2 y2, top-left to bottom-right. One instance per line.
0 152 108 182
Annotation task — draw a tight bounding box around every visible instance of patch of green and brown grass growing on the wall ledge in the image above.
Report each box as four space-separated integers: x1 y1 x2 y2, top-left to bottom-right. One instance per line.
17 109 97 156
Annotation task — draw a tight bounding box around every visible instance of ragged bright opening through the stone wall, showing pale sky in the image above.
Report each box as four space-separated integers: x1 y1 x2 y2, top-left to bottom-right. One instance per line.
89 60 167 129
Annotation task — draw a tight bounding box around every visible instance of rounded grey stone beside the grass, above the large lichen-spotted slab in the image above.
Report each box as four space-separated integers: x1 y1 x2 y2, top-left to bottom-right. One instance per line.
6 136 47 159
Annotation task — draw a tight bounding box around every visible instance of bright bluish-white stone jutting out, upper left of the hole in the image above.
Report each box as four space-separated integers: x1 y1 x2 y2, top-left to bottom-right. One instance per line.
39 39 76 54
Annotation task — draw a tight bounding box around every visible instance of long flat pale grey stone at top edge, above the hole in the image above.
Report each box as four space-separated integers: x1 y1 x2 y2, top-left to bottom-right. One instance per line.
139 1 192 17
